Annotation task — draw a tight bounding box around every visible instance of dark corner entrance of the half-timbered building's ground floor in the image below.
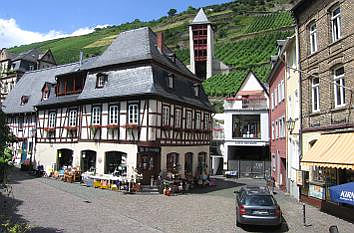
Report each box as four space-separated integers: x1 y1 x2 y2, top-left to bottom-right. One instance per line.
137 147 161 185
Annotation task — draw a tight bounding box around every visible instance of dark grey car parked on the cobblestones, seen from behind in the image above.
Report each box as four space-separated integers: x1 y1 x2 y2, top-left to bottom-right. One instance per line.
235 186 282 227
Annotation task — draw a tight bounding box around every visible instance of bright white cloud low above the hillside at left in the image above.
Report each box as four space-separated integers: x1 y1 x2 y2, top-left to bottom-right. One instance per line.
0 18 109 48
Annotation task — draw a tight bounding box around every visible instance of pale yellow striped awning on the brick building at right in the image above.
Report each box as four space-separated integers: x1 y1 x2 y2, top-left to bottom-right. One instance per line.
301 132 354 170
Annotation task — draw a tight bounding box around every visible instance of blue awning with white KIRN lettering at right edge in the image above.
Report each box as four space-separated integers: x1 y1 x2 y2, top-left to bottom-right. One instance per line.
329 182 354 205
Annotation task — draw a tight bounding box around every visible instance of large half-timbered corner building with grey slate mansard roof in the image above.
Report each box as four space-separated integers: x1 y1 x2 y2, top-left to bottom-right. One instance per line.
9 28 212 183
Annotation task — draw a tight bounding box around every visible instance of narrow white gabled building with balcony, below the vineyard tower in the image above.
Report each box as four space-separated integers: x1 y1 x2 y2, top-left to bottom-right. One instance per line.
223 72 270 177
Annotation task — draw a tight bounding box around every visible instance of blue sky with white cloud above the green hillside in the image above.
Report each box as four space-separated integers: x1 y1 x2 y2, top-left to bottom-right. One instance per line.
0 0 230 47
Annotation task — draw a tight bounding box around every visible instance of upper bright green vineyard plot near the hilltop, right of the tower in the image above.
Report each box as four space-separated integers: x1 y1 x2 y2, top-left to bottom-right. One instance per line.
245 11 294 33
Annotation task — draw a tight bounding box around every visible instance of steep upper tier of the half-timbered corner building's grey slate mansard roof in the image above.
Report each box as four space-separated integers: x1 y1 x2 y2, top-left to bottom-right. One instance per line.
81 27 198 79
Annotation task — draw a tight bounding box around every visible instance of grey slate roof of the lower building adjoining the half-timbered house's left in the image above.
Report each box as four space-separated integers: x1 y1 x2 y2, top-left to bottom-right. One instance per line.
2 63 79 114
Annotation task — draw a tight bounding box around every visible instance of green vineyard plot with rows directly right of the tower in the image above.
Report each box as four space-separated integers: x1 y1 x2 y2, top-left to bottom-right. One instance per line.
215 32 291 67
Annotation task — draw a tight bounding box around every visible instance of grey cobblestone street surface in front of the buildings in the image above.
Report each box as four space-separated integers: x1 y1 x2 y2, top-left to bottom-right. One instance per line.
2 169 354 233
